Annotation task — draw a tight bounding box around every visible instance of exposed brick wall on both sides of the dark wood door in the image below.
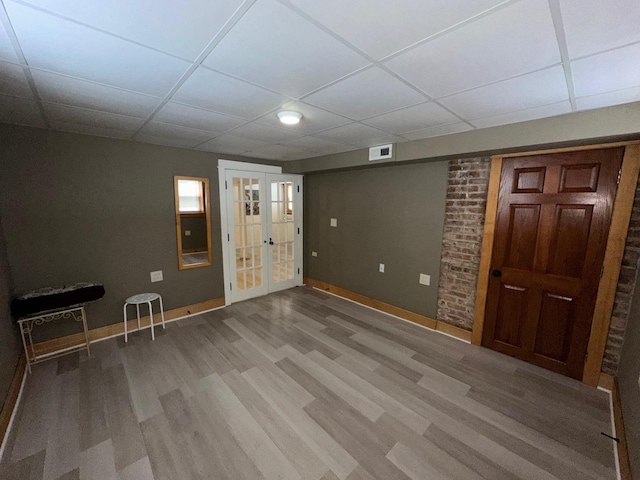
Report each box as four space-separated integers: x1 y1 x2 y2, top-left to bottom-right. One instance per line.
436 158 640 375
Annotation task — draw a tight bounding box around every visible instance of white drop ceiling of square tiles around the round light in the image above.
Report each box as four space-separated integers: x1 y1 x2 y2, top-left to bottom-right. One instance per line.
0 0 640 160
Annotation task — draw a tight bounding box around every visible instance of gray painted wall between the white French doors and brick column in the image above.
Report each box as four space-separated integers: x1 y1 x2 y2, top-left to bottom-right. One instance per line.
304 161 448 318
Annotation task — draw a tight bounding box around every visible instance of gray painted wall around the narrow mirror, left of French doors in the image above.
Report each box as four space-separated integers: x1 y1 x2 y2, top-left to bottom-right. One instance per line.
0 125 272 334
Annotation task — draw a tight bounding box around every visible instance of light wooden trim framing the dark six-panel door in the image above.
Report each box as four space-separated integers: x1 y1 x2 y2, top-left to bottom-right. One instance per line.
471 141 640 387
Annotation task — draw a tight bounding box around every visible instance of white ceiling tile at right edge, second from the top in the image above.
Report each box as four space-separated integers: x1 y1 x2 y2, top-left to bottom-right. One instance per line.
571 44 640 97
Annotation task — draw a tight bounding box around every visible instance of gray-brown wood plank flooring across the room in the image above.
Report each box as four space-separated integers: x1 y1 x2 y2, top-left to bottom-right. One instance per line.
0 287 616 480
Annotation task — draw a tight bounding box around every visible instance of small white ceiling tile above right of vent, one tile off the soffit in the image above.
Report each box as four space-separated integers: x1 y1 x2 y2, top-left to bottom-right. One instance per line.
363 102 460 134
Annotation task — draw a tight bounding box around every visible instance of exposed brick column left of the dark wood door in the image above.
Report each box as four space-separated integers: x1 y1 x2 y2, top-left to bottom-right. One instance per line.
436 158 491 330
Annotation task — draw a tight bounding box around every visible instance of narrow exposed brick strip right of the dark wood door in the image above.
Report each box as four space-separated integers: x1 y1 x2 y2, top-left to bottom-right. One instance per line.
602 176 640 375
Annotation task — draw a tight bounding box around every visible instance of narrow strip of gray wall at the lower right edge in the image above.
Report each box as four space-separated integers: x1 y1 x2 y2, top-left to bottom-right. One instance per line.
617 268 640 479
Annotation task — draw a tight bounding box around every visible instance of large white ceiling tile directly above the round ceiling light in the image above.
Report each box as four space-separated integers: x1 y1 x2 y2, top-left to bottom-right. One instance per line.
204 0 369 97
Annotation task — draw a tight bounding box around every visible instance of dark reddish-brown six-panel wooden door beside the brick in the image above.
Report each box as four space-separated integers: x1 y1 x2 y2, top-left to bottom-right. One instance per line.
482 148 624 378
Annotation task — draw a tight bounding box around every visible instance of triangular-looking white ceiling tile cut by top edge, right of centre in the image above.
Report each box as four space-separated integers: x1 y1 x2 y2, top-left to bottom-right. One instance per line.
291 0 502 59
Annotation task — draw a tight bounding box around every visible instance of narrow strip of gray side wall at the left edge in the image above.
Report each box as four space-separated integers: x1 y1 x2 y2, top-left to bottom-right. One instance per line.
0 215 22 409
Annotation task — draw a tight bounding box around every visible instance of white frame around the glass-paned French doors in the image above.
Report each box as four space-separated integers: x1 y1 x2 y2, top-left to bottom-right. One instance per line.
218 159 303 305
